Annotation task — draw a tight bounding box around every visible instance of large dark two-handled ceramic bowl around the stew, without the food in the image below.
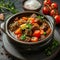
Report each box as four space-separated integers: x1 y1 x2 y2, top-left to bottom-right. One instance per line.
1 11 54 50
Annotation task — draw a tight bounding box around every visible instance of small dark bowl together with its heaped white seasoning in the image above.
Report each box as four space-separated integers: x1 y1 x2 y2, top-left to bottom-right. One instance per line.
23 0 42 11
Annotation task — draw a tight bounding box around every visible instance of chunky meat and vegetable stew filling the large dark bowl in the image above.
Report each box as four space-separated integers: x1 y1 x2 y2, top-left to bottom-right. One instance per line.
9 14 51 42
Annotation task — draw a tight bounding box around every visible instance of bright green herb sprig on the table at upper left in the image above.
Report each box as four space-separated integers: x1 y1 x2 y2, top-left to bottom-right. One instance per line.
0 0 18 14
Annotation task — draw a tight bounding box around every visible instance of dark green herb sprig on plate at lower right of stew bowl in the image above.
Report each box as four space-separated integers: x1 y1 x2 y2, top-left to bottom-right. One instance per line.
44 39 59 56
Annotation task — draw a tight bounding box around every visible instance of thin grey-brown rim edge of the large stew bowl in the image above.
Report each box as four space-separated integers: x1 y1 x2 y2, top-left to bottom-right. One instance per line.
5 11 54 45
